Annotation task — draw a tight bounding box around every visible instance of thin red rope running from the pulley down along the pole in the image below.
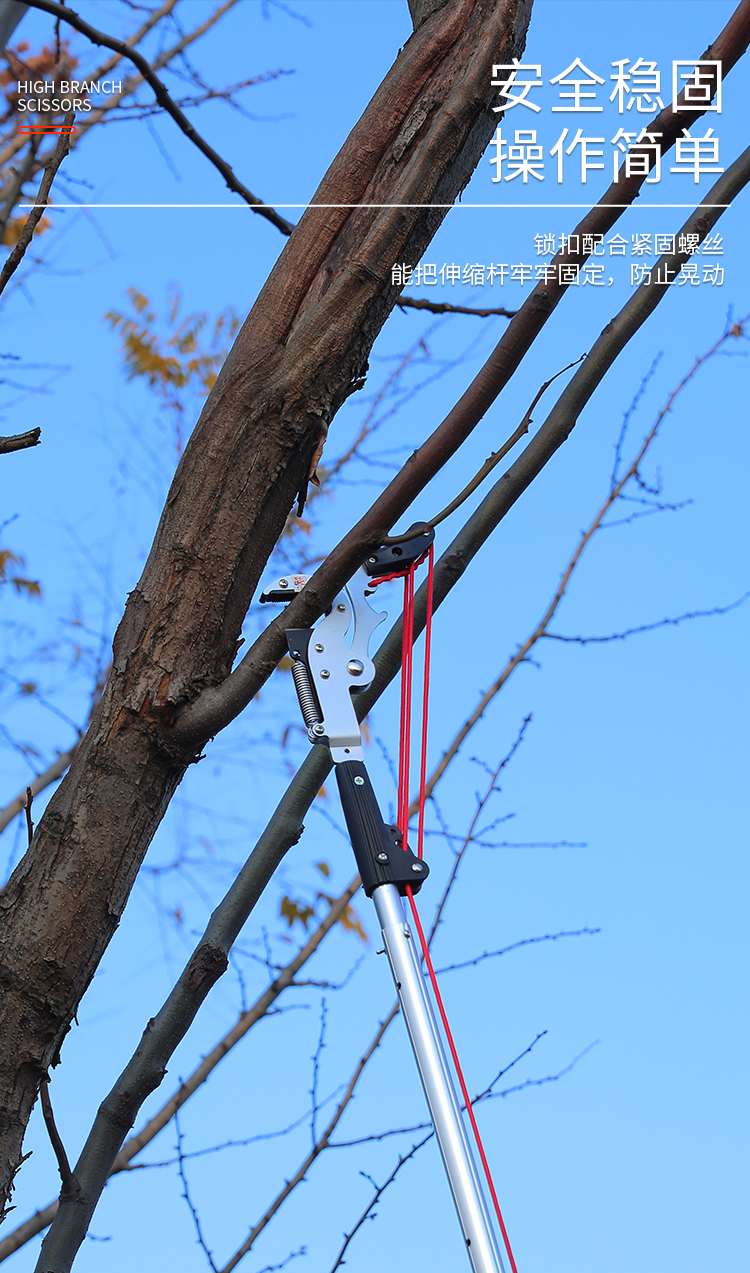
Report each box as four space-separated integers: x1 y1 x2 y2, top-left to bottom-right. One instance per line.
389 544 518 1273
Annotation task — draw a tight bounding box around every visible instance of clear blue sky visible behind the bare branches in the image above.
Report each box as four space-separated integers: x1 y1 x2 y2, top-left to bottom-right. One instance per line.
0 7 750 1273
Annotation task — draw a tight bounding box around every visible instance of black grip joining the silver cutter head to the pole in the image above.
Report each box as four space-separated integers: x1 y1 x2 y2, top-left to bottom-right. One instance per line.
335 760 429 897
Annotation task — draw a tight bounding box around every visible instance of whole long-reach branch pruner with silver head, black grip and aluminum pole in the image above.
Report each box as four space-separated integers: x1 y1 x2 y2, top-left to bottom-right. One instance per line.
273 549 506 1273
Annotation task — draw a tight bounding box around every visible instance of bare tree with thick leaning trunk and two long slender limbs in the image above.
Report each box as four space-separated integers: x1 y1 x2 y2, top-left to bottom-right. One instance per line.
3 3 747 1268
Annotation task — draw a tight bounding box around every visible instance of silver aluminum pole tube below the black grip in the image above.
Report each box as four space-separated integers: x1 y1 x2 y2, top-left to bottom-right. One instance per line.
372 883 504 1273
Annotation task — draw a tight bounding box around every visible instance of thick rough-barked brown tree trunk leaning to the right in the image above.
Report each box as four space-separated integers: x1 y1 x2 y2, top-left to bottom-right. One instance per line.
0 0 531 1204
